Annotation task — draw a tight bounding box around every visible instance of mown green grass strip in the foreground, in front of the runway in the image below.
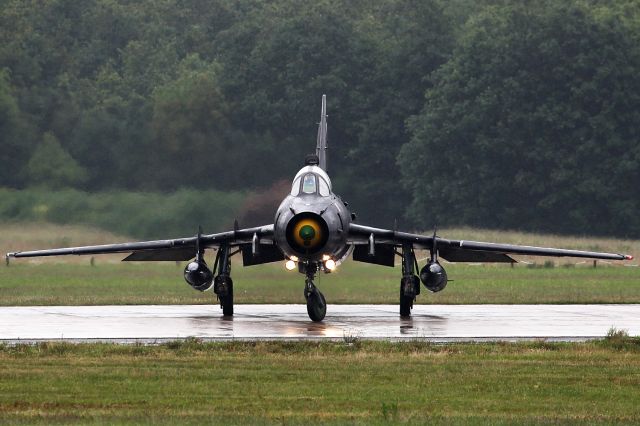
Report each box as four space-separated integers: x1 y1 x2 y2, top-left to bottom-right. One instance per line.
0 338 640 424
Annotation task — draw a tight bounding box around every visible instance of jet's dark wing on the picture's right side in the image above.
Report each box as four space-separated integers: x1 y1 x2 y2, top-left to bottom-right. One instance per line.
349 223 633 262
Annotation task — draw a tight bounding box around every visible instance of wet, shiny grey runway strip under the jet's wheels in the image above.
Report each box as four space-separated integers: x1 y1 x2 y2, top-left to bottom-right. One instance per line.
0 305 640 343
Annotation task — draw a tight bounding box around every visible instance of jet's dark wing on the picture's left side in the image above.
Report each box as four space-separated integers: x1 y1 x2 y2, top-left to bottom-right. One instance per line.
7 225 273 261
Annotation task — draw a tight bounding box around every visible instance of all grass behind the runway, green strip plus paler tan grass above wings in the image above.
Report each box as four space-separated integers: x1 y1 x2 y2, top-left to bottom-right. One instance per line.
0 221 640 306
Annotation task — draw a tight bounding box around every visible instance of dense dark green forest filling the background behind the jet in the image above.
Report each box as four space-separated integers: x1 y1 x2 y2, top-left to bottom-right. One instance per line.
0 0 640 238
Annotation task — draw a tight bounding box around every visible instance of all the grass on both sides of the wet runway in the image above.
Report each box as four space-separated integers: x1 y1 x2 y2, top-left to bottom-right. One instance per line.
0 225 640 425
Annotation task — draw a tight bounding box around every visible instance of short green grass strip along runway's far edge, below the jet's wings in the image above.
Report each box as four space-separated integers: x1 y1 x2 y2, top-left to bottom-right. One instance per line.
0 262 640 306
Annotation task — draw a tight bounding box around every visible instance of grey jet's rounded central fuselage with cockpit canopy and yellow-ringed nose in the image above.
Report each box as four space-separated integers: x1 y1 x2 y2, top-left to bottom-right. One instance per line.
274 165 351 270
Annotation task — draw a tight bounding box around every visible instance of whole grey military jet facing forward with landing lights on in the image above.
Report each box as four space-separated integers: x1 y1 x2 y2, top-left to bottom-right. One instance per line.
7 95 633 321
